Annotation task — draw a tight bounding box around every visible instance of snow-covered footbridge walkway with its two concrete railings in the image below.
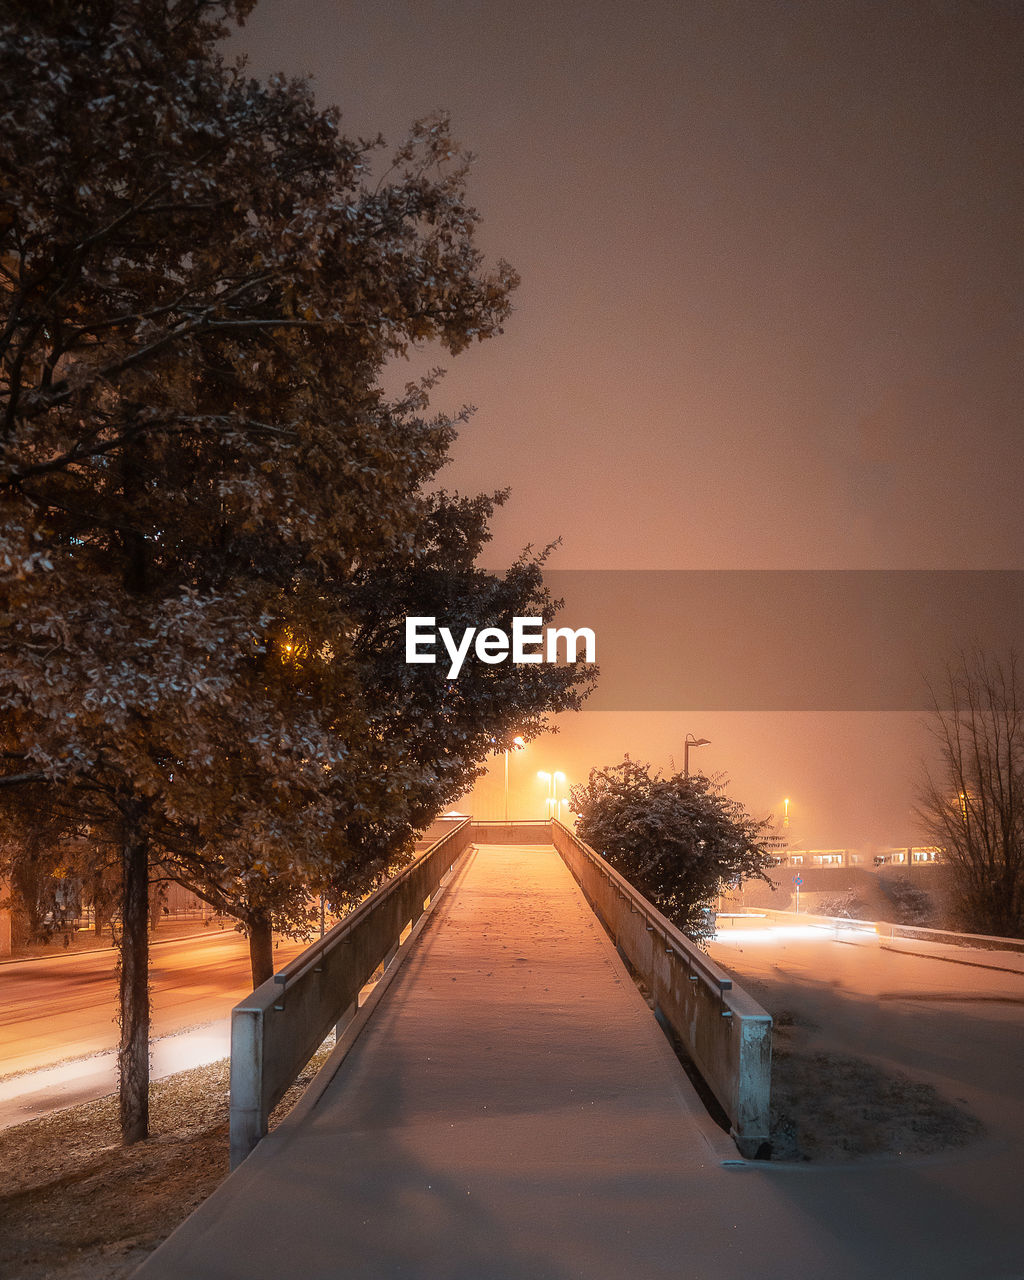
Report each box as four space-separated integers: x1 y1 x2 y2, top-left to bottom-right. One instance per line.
133 820 783 1280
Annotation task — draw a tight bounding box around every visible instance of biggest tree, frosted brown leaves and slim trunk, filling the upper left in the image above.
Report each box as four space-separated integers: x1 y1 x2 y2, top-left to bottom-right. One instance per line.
0 0 591 1140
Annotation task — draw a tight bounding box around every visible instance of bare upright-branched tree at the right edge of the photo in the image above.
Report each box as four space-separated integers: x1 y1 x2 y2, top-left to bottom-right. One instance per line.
918 652 1024 937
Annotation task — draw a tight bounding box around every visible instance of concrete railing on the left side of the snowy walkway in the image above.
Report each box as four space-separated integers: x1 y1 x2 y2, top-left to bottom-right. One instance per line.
230 819 472 1169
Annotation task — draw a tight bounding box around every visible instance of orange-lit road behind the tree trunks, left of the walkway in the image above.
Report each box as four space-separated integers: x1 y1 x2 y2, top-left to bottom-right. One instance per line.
0 931 305 1076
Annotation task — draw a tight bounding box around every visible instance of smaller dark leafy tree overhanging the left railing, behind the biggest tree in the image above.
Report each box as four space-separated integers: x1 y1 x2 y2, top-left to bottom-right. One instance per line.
145 512 595 983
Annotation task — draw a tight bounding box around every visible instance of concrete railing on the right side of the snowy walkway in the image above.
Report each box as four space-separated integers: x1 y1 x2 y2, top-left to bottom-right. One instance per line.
552 822 772 1157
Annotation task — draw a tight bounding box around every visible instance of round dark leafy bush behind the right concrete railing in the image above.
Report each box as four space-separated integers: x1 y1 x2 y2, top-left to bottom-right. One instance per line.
570 755 778 942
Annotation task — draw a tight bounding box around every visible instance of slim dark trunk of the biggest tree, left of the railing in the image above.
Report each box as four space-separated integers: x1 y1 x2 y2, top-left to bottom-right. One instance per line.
118 806 150 1146
